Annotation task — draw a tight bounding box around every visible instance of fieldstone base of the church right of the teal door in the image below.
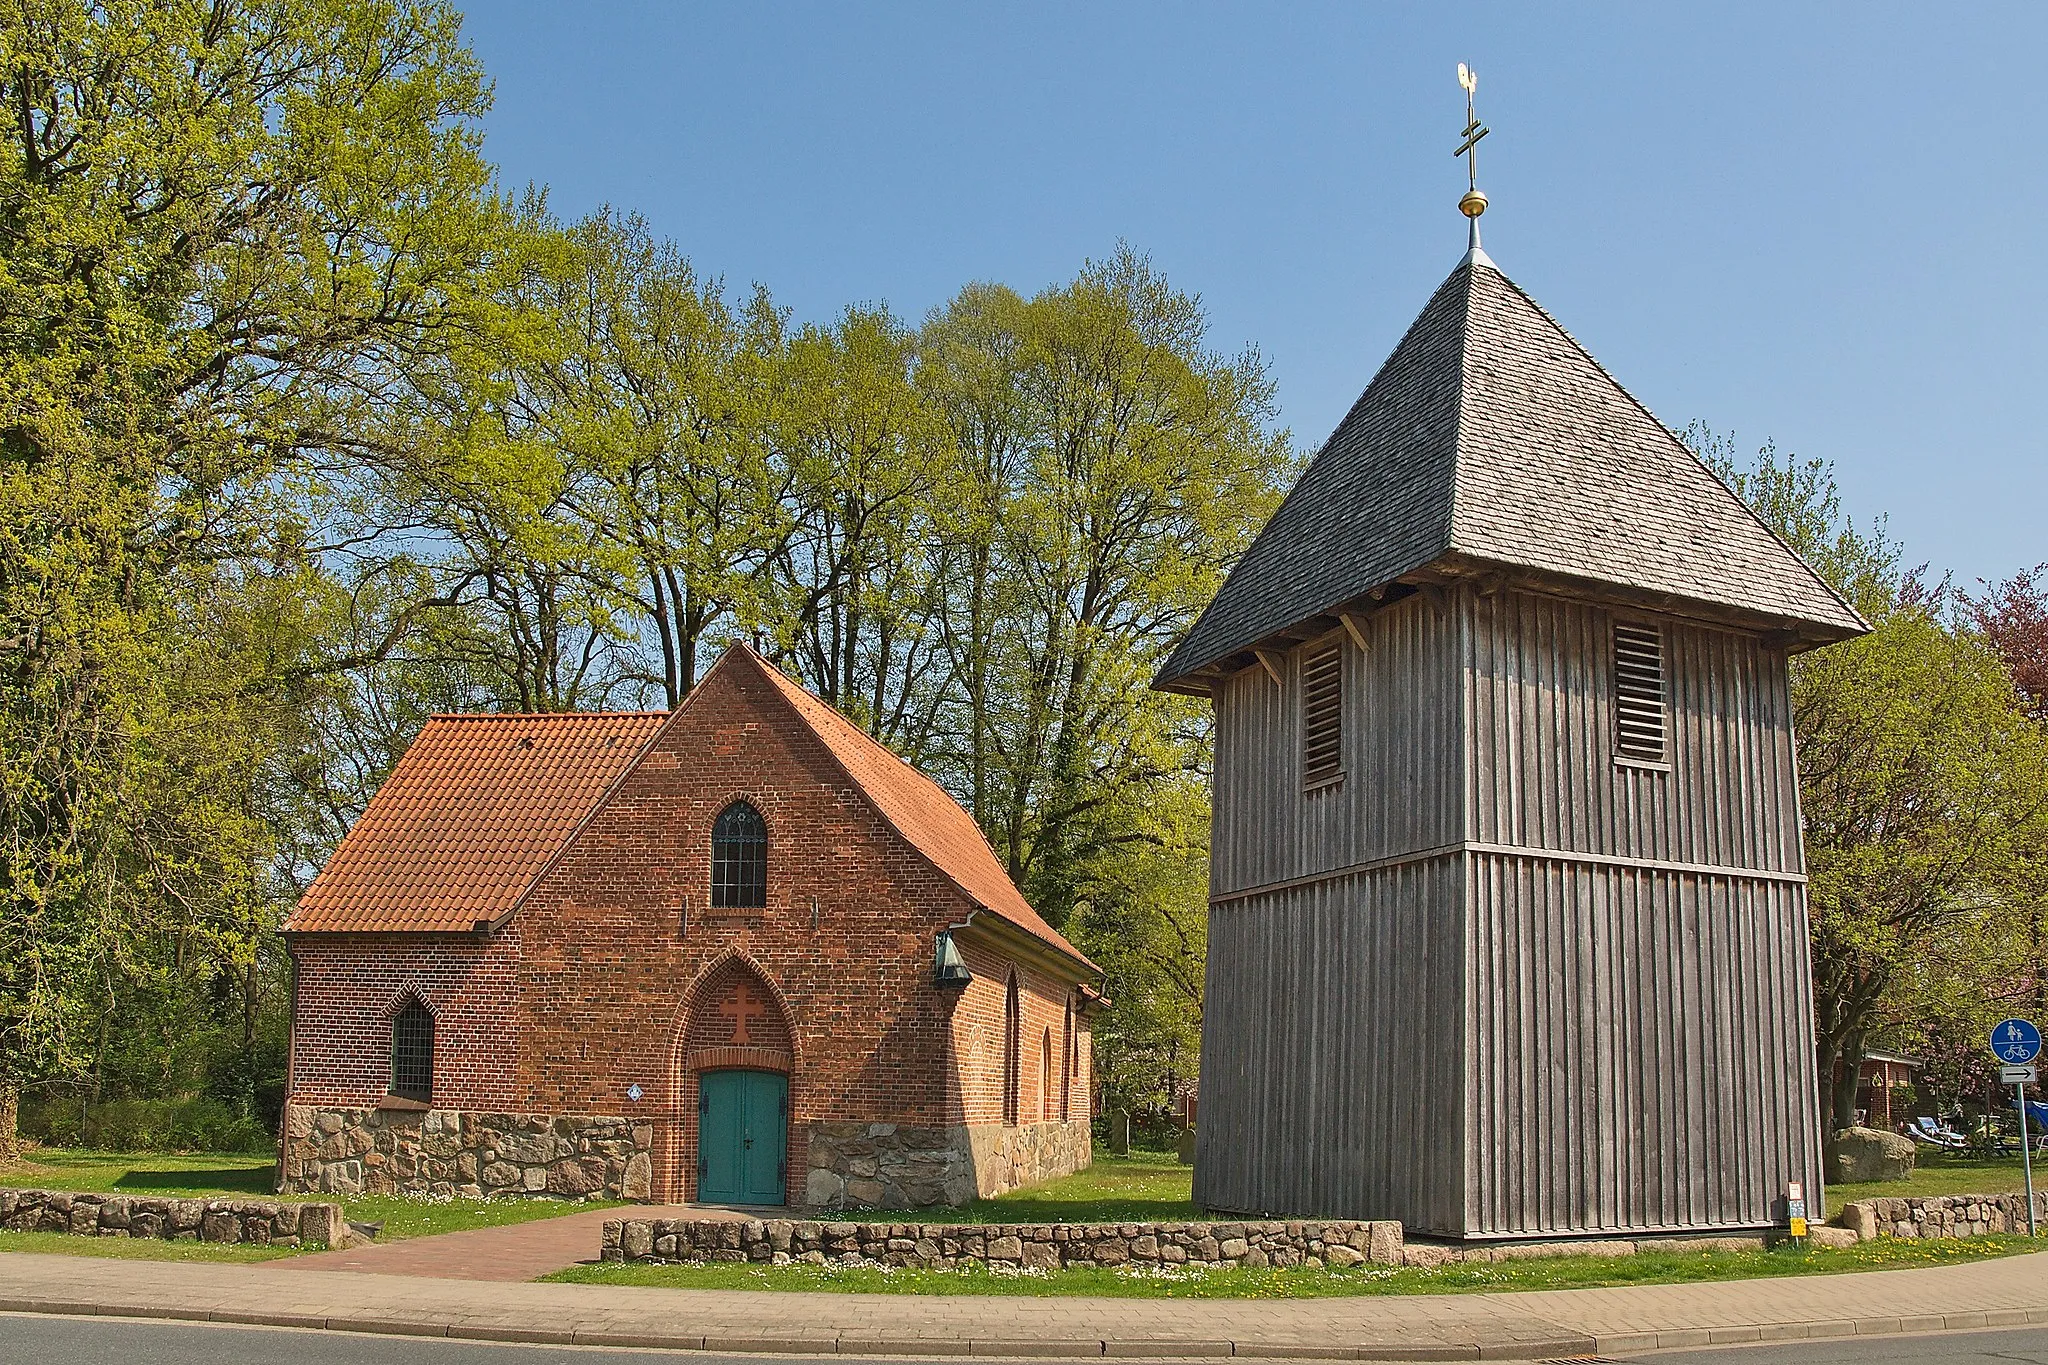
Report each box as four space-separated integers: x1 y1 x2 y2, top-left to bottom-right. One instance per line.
803 1121 1094 1212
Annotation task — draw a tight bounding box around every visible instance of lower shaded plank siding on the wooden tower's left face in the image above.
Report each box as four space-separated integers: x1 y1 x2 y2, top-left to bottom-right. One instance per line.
1194 855 1464 1228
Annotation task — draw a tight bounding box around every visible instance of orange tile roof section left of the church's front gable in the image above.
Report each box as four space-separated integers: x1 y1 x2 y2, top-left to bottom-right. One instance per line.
285 710 668 933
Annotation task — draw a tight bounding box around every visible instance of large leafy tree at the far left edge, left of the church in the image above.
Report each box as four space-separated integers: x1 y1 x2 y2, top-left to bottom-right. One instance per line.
0 0 506 1154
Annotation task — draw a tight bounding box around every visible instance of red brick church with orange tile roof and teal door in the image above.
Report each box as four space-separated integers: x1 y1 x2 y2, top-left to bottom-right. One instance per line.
279 647 1102 1209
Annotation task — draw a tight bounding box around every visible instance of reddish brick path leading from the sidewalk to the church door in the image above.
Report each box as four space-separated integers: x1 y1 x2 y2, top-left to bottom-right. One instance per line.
272 1205 760 1283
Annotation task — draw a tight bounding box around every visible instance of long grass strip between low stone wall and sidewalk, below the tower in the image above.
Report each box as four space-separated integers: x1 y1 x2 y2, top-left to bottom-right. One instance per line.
547 1236 2040 1300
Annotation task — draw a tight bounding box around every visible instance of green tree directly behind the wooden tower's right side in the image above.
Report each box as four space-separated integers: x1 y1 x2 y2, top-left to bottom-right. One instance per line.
1688 426 2048 1132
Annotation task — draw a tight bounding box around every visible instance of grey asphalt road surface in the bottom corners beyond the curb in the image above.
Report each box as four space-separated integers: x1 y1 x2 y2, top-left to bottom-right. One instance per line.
0 1314 2048 1365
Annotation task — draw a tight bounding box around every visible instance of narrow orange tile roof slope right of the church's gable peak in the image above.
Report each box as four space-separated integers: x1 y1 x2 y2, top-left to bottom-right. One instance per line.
741 645 1102 972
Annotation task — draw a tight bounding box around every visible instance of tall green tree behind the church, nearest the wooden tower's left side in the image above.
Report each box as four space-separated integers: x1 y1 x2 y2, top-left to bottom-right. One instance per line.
926 248 1294 923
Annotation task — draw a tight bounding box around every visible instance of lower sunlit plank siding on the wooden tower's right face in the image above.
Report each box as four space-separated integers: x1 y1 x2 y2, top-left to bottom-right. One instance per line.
1460 853 1819 1236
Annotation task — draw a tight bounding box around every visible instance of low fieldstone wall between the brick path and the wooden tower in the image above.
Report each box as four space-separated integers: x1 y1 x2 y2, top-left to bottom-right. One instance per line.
602 1218 1401 1271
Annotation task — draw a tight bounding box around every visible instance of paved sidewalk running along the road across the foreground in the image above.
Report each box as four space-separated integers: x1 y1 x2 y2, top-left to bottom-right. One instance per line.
0 1252 2048 1361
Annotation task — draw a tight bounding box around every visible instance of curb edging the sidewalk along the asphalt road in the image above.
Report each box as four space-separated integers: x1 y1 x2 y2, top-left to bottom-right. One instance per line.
12 1297 2048 1361
